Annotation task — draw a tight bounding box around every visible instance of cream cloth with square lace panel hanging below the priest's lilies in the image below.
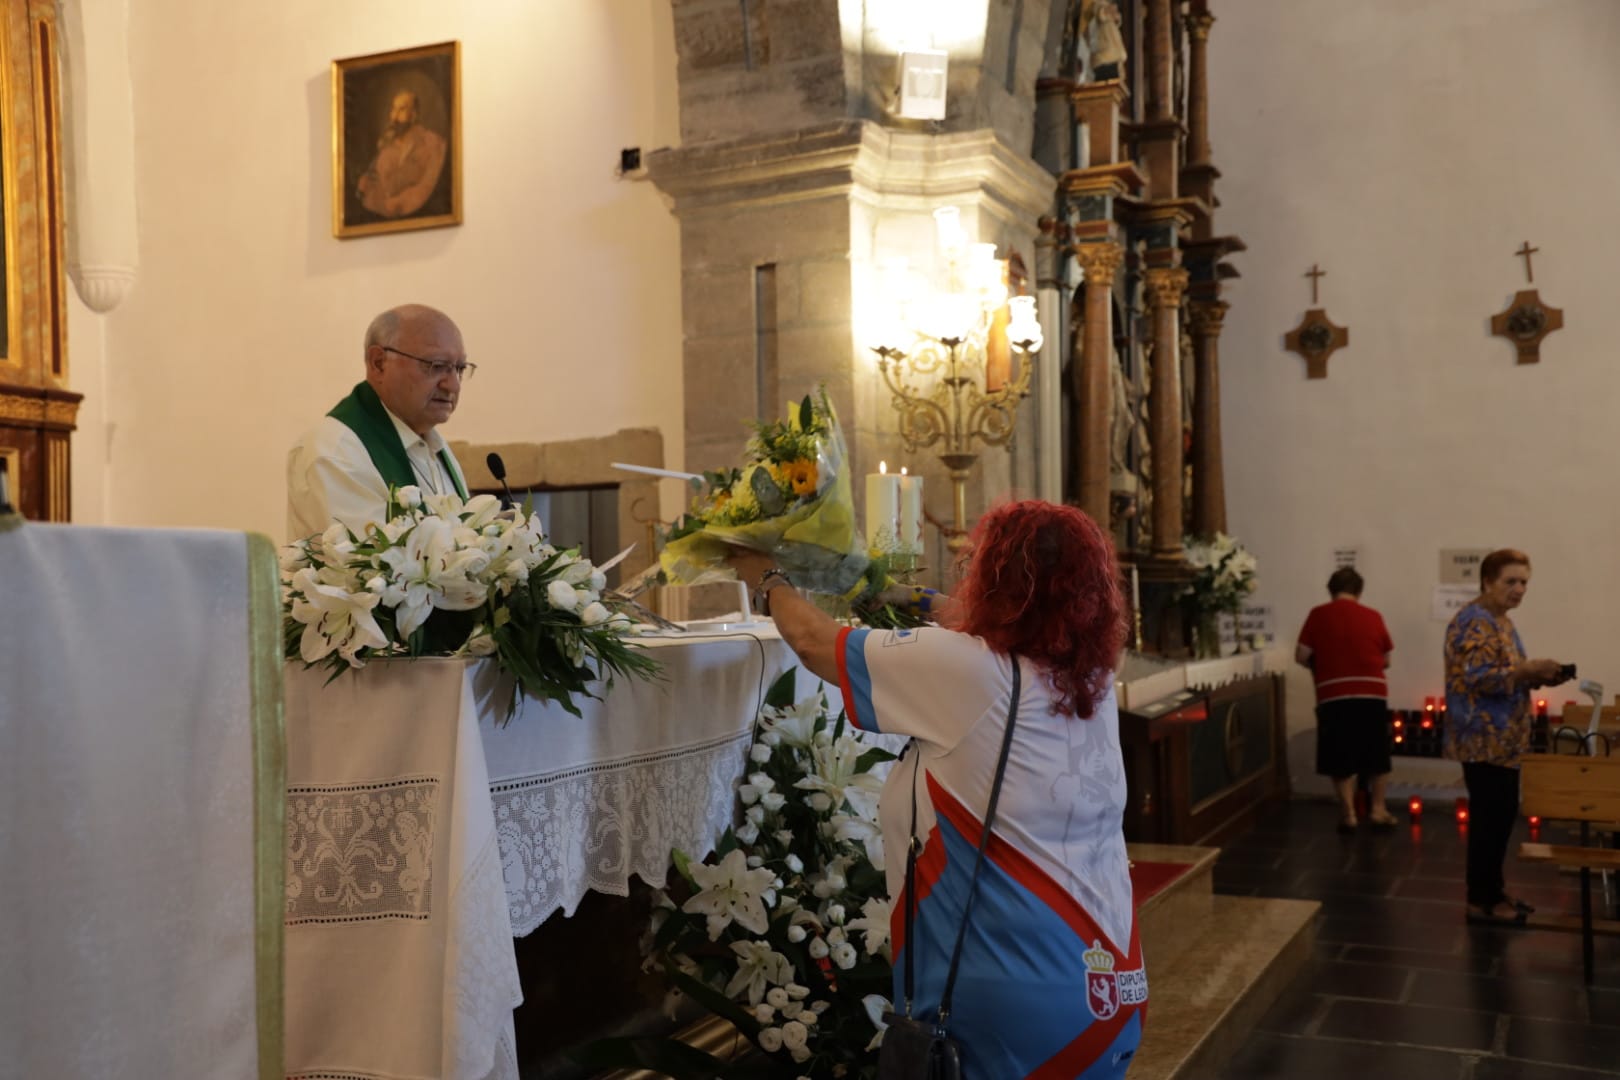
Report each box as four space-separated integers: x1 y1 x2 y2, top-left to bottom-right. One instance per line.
285 659 522 1080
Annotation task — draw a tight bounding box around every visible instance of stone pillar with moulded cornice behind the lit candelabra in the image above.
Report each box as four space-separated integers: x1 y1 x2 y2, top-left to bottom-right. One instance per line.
648 120 1061 553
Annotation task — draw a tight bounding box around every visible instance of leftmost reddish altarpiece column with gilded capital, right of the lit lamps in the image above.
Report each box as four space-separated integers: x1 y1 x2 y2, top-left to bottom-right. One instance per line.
1074 241 1121 524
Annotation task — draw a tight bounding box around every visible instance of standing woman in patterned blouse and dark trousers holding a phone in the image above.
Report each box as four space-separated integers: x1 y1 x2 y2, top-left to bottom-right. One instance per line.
1445 547 1562 925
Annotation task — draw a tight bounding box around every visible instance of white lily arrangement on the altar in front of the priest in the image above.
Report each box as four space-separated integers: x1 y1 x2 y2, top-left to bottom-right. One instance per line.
282 487 658 717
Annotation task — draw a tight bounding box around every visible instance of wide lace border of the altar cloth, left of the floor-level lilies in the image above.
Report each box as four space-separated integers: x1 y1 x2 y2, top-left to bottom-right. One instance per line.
489 732 752 938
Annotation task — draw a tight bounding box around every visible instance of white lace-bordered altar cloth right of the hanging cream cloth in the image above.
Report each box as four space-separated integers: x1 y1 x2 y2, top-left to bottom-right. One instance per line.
475 623 810 938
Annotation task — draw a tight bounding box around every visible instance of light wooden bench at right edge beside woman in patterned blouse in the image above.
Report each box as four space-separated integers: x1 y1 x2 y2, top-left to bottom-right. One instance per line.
1520 755 1620 983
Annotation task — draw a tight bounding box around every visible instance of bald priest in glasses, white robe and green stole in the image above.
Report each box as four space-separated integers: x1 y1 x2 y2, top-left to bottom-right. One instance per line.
287 304 475 539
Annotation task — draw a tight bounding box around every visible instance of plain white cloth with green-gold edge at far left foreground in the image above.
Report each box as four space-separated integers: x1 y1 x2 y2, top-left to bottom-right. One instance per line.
0 520 282 1080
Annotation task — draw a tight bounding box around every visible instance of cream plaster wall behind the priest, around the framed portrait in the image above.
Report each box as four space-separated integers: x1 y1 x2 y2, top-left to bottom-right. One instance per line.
71 0 682 538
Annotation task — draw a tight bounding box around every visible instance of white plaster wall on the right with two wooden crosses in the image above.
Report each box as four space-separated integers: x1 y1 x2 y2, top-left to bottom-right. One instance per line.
1210 0 1620 779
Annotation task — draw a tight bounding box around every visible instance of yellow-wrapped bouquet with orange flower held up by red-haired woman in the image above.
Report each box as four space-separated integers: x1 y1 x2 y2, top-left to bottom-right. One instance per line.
661 389 870 594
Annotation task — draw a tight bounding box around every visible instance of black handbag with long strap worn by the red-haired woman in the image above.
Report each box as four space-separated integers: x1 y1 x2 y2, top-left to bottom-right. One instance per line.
878 656 1022 1080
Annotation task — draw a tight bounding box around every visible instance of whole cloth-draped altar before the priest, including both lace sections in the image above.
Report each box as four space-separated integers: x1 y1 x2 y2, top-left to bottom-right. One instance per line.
285 623 812 1078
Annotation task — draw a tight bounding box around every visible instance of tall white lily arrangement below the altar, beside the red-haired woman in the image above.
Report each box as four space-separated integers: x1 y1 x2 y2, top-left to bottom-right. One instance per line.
580 669 894 1080
